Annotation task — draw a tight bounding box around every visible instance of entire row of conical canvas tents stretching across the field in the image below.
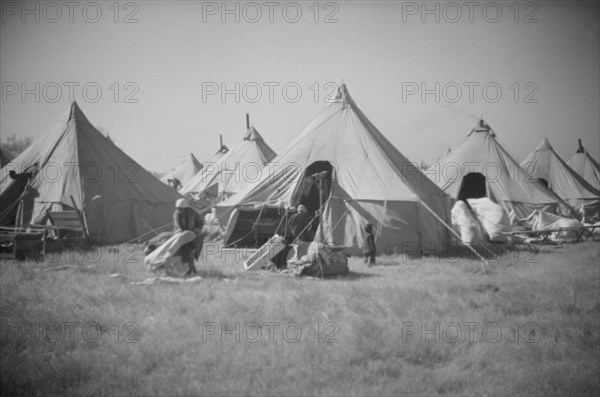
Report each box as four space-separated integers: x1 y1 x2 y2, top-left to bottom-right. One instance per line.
0 85 600 252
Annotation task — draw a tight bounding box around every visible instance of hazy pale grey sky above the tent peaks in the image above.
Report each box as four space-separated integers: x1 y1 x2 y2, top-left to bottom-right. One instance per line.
0 1 600 171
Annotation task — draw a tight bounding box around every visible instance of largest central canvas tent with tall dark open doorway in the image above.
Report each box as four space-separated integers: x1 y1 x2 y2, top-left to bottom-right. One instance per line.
218 85 452 253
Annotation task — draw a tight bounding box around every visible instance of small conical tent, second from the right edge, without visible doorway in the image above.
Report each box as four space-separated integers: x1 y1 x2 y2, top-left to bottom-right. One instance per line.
521 138 600 212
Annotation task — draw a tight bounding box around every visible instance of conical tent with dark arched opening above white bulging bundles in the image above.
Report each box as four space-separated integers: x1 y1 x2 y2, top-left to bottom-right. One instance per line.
426 120 570 218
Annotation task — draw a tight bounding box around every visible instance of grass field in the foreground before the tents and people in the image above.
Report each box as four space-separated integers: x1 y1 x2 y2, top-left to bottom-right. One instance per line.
0 242 600 396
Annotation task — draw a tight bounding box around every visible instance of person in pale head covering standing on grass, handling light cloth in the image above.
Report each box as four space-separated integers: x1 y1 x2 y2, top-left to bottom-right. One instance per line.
173 199 204 274
